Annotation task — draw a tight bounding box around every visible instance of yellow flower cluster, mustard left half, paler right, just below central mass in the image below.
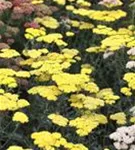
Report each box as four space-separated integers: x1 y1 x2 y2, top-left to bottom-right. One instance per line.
69 94 104 110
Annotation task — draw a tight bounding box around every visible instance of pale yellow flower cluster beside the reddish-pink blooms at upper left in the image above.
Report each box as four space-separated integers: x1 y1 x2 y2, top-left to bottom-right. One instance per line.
34 16 59 29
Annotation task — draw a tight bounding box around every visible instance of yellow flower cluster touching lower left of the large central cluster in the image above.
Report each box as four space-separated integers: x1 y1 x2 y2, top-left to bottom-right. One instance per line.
28 85 61 101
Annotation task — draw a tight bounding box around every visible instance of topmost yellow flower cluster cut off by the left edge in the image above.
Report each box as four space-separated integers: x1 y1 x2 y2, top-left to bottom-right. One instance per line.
0 49 20 58
